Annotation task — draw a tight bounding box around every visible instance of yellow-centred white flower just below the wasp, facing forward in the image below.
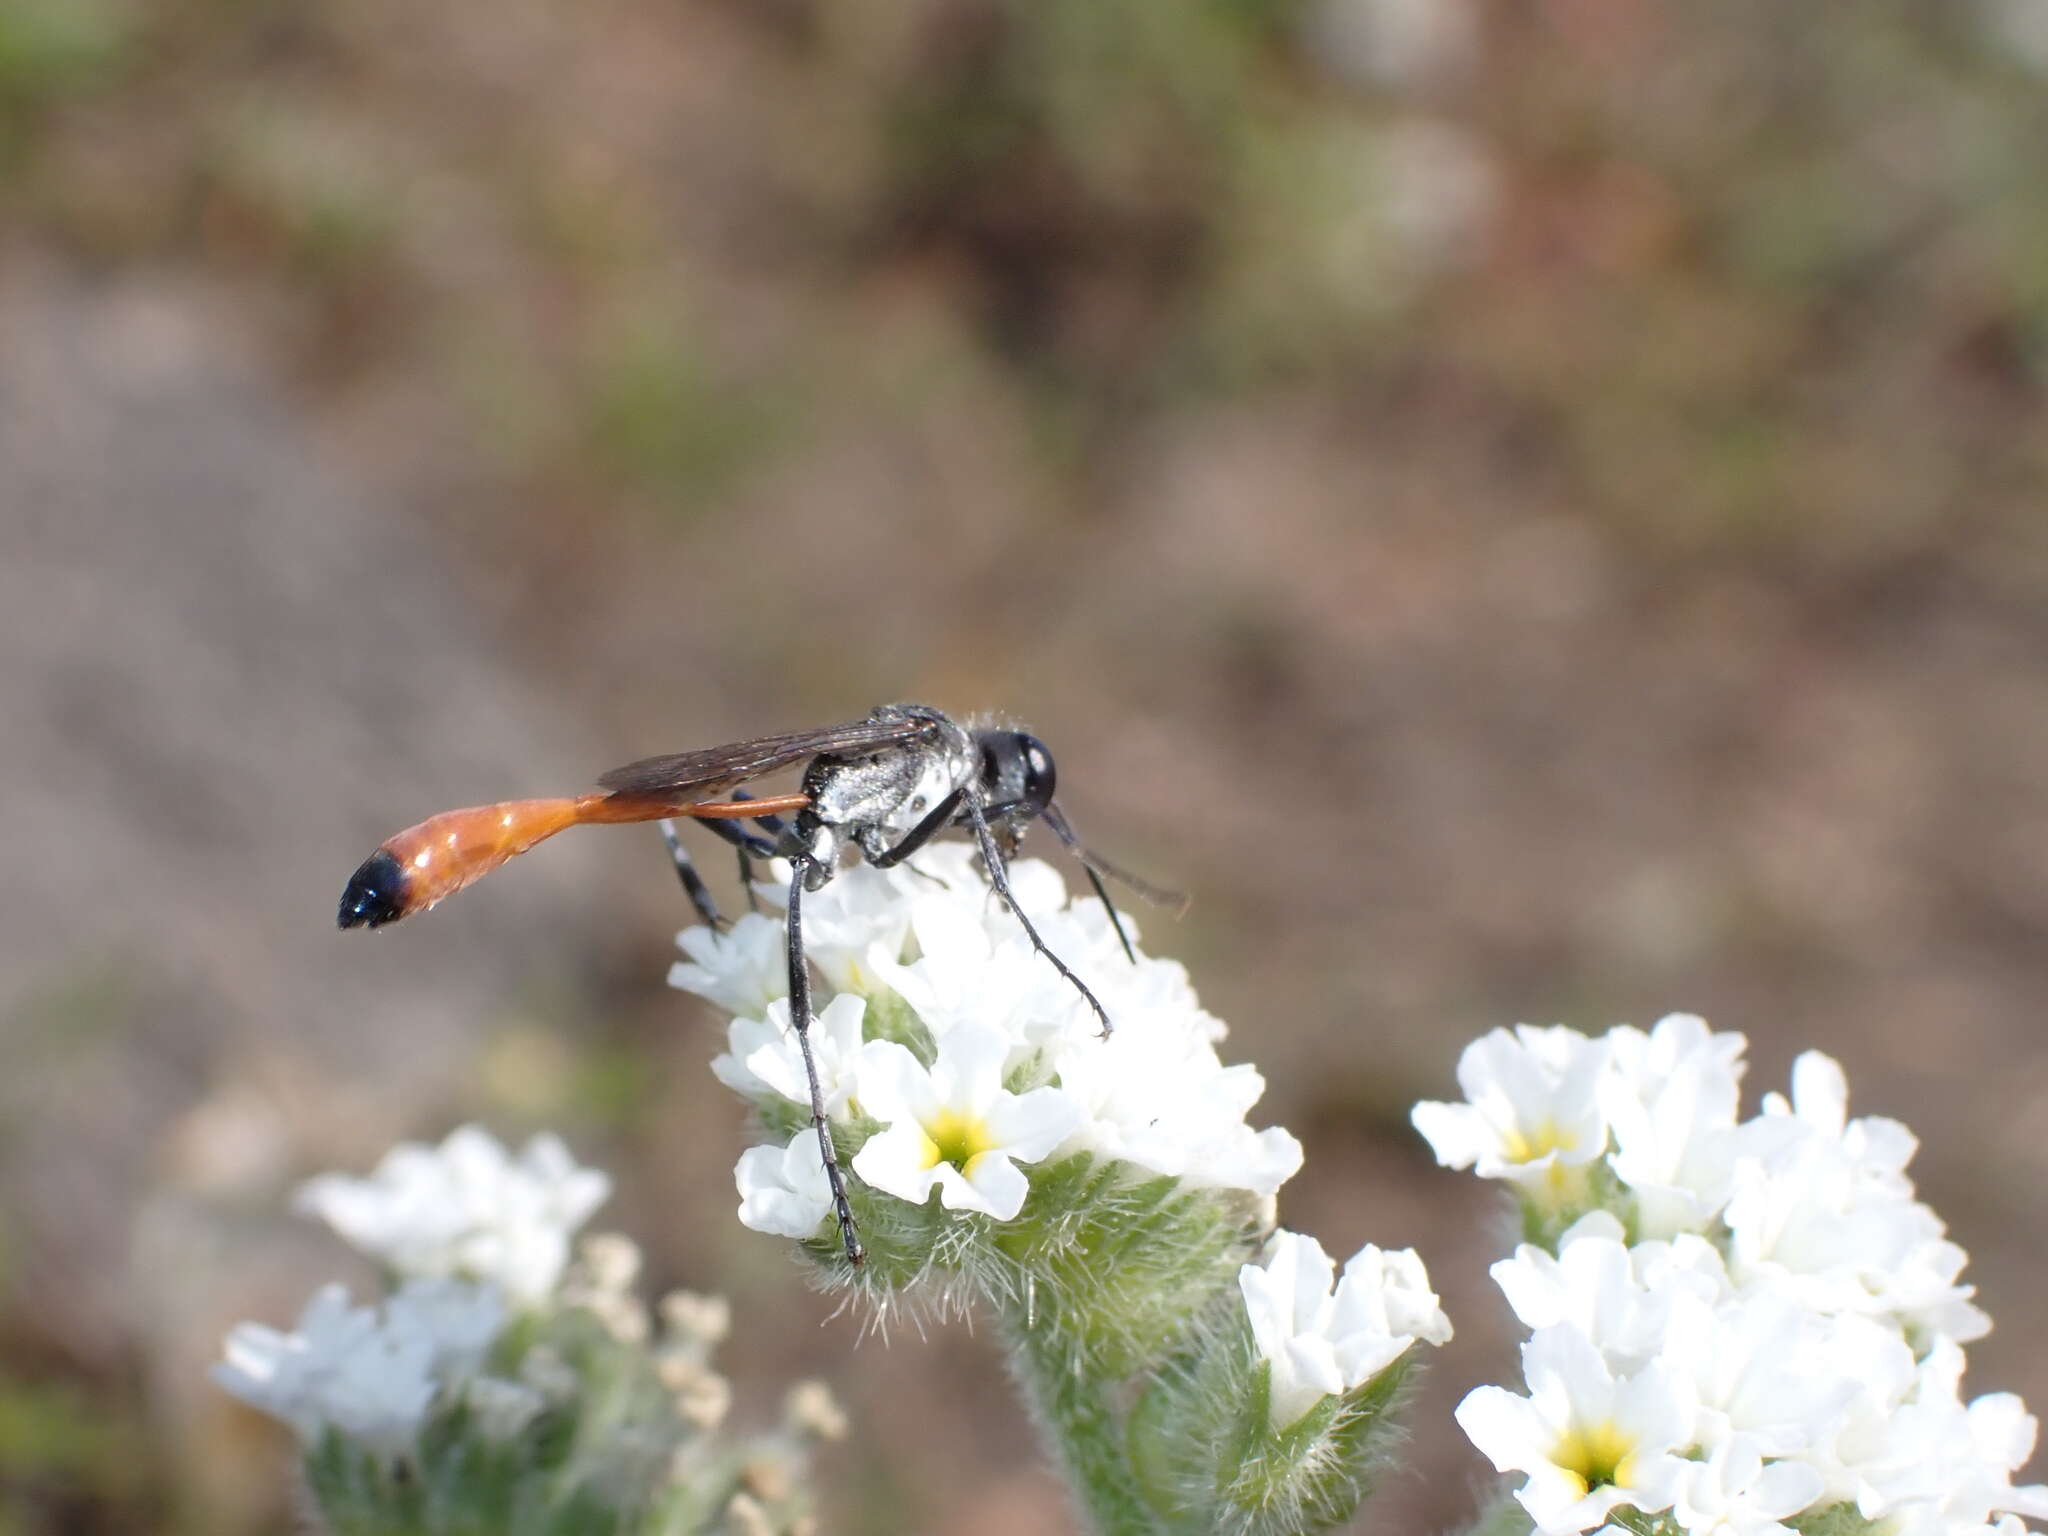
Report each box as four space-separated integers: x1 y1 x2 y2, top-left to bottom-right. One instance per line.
854 1024 1079 1221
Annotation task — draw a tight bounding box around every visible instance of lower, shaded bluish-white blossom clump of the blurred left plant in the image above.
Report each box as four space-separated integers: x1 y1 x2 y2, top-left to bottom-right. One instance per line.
213 1280 506 1456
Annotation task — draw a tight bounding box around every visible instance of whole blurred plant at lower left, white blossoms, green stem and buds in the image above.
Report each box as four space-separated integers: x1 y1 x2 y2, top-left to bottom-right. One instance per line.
213 1126 846 1536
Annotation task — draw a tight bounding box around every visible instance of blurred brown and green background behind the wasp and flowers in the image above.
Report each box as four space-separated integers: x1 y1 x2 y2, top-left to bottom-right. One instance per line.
0 0 2048 1536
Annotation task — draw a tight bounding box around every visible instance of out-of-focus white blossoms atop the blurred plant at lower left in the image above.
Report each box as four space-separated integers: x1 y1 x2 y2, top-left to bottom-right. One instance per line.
213 1126 610 1456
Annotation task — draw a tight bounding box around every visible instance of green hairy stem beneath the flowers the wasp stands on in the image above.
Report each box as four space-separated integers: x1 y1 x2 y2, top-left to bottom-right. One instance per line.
811 1157 1409 1536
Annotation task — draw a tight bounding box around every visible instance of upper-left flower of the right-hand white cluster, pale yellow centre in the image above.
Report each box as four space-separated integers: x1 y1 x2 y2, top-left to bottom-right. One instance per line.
1411 1024 1608 1202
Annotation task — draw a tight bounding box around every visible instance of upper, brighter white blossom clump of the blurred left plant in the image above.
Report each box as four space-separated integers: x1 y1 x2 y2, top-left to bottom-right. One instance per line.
293 1126 612 1307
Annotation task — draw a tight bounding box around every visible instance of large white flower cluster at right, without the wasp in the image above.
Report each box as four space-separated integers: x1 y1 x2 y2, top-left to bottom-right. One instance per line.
1415 1016 2048 1536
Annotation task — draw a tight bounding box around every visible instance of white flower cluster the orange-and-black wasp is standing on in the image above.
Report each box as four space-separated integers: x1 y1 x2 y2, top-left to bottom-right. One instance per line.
670 844 1300 1237
